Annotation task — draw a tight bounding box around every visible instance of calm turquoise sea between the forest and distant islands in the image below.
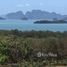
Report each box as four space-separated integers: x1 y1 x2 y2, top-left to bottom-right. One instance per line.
0 20 67 32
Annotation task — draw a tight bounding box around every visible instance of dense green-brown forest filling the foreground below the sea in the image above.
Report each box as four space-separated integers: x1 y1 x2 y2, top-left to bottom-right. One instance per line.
0 30 67 67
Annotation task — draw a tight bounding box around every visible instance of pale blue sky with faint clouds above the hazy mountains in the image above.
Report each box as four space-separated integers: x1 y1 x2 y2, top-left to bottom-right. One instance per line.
0 0 67 15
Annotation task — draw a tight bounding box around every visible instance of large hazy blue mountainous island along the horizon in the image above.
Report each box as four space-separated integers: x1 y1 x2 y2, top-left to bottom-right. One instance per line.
0 10 67 20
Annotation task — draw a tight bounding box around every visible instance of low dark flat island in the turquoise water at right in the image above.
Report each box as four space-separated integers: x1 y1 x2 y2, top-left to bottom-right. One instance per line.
34 20 67 24
